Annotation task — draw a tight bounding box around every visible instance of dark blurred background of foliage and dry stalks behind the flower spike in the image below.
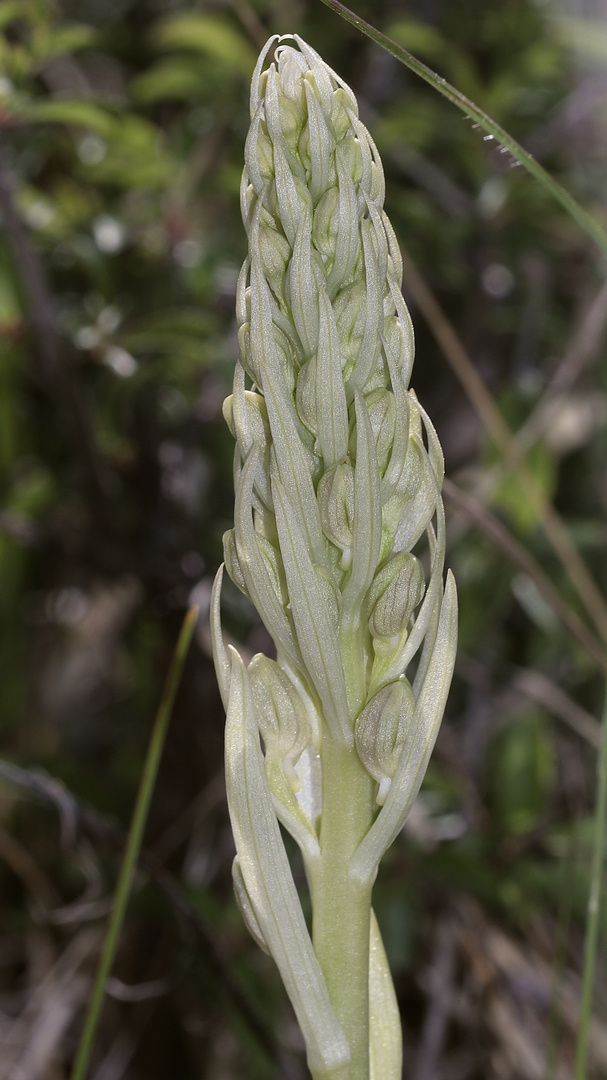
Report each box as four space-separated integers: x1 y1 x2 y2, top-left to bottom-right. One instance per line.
0 0 607 1080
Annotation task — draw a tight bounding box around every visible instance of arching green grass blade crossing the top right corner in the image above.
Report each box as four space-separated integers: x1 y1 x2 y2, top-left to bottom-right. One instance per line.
313 0 607 255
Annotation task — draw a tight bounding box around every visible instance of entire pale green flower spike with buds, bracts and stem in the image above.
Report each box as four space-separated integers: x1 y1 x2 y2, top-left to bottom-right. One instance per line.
212 36 457 1080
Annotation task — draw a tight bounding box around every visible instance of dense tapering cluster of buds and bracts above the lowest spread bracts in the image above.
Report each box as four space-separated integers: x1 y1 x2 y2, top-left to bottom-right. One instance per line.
214 39 451 794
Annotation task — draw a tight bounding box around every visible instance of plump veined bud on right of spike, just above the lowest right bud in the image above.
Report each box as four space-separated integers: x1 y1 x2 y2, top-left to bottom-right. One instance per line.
367 551 424 639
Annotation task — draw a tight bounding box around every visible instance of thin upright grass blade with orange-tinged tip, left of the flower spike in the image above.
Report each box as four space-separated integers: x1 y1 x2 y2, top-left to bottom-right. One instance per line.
71 607 198 1080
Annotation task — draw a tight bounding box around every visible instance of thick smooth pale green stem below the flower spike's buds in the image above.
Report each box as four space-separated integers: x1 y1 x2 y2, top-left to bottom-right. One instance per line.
310 733 374 1080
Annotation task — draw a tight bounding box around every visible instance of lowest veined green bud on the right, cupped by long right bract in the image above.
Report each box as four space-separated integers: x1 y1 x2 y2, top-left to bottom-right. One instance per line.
354 675 415 806
